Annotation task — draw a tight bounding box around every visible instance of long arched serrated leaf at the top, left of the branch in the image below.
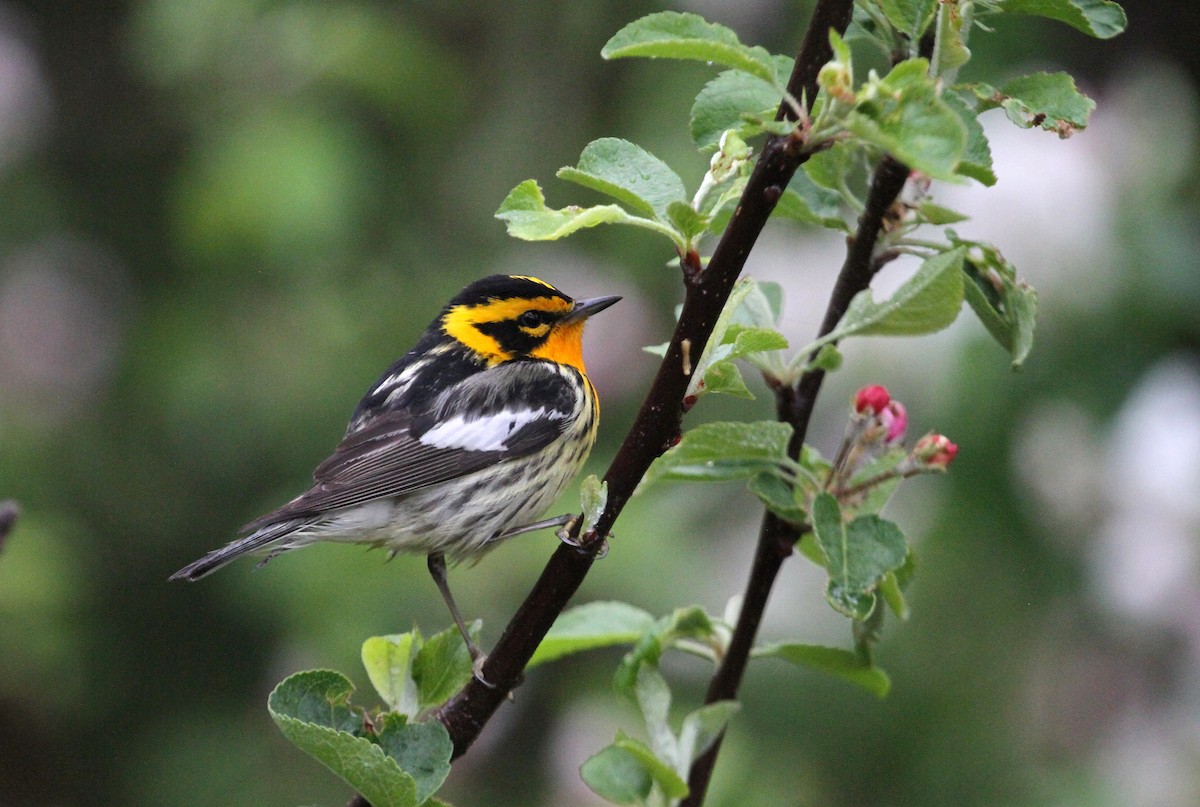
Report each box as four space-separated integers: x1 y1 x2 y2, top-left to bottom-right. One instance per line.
600 11 779 84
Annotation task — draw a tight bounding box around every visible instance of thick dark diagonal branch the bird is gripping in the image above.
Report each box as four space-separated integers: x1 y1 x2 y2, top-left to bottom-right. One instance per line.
436 0 853 757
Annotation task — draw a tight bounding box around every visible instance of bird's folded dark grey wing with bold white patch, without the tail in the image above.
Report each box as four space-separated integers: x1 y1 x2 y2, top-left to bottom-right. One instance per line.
244 361 576 531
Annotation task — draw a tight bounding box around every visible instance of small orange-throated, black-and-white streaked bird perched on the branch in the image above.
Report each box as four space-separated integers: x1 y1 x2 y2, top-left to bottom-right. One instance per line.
170 275 620 669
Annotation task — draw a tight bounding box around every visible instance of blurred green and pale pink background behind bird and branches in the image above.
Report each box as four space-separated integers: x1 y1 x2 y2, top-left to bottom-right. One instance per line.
0 0 1200 807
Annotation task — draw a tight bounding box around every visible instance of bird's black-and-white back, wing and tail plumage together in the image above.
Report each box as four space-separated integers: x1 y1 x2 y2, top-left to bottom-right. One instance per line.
172 360 585 580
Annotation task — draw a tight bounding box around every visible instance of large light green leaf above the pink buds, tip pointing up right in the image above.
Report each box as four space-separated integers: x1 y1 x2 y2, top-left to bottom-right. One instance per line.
825 247 964 345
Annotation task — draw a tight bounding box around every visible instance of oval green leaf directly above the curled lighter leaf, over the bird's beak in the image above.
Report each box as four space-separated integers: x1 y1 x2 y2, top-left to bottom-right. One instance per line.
557 137 686 218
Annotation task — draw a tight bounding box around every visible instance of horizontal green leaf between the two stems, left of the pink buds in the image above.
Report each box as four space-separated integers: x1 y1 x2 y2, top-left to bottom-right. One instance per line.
646 420 792 484
